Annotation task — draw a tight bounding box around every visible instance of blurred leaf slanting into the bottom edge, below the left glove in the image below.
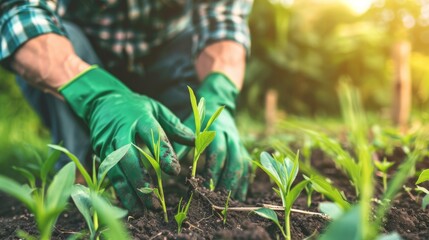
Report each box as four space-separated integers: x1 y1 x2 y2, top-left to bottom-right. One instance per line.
91 194 131 240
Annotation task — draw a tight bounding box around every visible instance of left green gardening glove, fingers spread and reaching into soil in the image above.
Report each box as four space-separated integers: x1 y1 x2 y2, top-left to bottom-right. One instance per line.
60 67 194 211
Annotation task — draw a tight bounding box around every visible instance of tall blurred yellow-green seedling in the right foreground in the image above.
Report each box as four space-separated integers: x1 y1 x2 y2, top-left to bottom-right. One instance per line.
314 85 427 240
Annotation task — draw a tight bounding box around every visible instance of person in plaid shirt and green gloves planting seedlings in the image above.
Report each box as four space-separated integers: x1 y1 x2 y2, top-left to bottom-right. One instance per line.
0 0 252 211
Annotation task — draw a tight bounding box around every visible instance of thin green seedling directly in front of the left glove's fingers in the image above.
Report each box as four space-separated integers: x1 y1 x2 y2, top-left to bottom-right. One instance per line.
134 130 168 223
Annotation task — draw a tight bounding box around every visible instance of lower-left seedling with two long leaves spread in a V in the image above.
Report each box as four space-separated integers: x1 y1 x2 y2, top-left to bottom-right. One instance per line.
49 144 131 239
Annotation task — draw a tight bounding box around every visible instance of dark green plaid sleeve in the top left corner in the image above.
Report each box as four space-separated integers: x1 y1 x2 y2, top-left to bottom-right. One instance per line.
0 0 65 64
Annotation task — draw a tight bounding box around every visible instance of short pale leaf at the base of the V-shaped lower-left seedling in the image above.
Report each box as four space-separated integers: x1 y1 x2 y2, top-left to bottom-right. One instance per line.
71 184 95 239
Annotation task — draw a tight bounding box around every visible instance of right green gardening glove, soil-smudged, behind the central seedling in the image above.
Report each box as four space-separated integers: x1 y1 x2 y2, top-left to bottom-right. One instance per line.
174 73 251 200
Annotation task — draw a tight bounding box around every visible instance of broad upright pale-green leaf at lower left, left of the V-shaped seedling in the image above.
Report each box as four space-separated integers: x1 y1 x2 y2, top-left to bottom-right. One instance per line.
46 162 76 211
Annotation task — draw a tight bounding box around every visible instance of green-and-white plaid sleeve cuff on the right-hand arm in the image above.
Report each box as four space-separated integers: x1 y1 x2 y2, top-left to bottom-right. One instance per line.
193 0 253 56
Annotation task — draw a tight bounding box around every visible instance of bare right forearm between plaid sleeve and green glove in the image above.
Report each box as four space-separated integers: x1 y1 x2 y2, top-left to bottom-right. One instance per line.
195 40 246 90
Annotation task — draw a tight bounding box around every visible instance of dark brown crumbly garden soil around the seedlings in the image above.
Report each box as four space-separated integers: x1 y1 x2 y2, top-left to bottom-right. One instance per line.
0 149 429 239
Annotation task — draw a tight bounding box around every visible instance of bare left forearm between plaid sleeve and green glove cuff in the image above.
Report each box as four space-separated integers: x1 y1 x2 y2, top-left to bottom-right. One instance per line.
11 33 89 97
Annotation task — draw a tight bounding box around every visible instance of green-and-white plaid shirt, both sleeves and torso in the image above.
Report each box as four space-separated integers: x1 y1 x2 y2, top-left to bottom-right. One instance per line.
0 0 252 68
